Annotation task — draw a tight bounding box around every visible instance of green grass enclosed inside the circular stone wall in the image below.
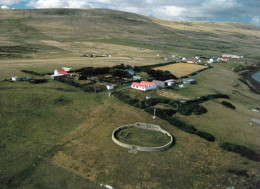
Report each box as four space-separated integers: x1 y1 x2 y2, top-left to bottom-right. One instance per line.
116 127 170 147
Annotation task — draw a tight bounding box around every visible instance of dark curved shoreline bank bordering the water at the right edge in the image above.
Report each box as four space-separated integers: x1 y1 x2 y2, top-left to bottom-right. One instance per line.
240 62 260 94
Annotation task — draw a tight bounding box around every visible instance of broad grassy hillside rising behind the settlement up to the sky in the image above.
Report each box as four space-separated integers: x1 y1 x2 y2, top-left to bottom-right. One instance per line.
0 9 260 57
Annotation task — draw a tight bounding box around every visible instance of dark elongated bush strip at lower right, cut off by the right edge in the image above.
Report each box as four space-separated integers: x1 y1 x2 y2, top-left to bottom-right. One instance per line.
219 142 260 161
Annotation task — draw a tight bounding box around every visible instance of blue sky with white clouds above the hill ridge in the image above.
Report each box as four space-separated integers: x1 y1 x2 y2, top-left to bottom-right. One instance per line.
0 0 260 26
